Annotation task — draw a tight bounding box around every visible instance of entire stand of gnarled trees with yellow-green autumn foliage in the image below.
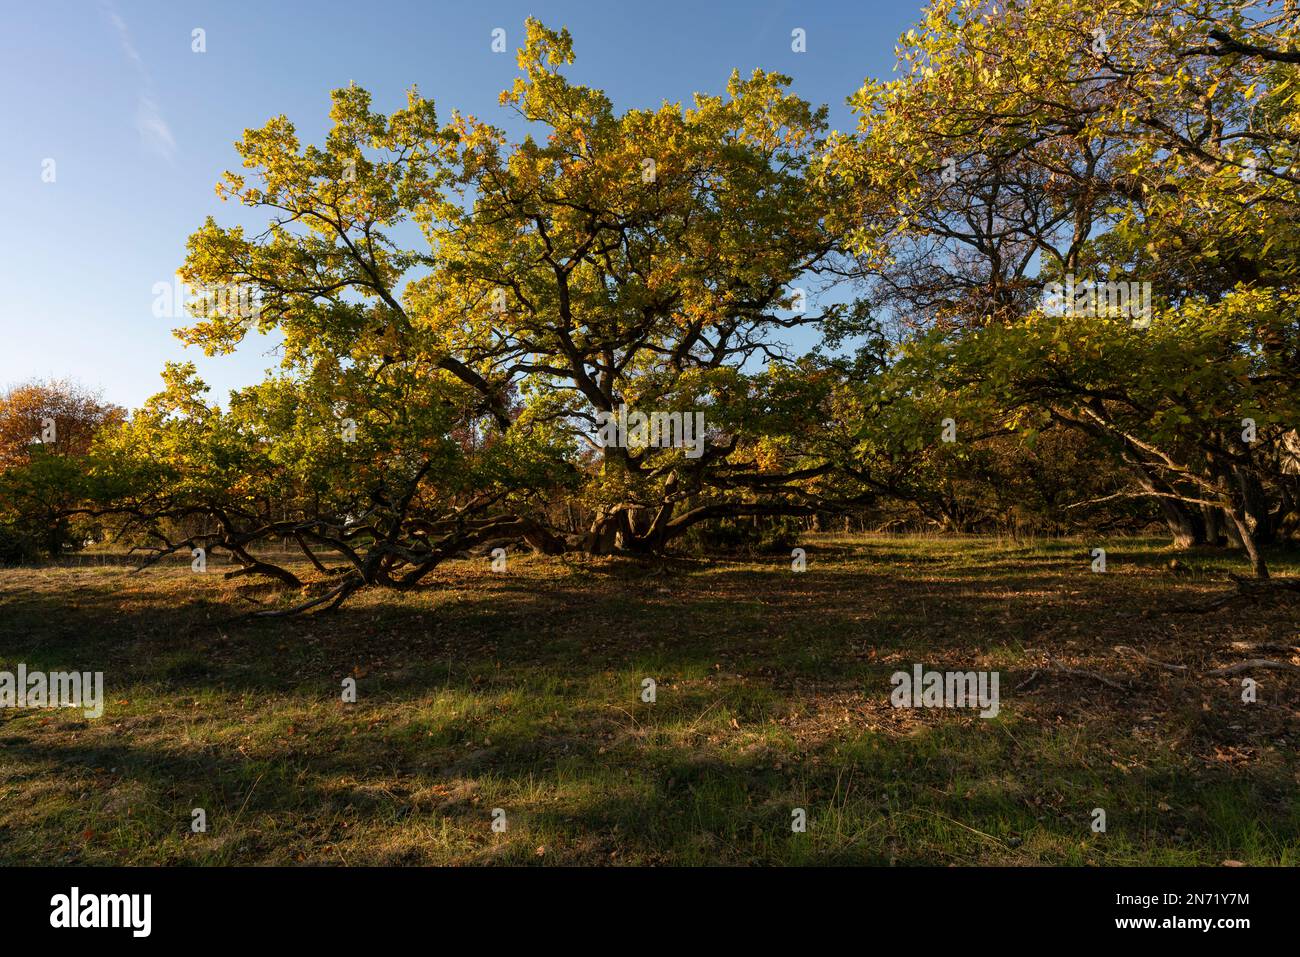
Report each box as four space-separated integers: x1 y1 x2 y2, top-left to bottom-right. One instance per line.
0 0 1300 610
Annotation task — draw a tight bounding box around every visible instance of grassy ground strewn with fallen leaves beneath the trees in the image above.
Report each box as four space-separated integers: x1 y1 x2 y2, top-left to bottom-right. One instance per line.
0 536 1300 866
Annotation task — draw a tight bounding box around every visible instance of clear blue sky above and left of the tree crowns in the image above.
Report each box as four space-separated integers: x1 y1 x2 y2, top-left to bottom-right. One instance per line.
0 0 920 407
